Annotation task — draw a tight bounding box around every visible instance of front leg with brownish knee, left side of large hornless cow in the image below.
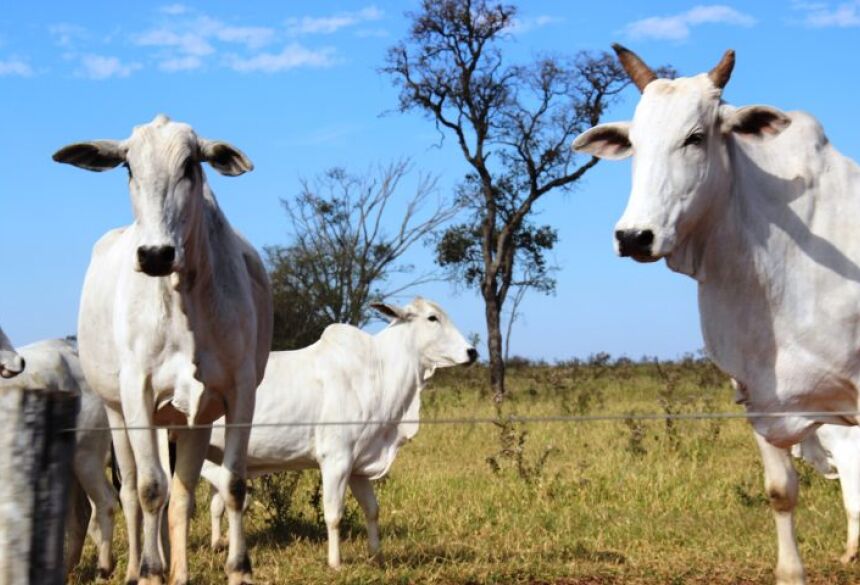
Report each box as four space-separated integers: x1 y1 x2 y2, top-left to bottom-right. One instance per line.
120 368 168 585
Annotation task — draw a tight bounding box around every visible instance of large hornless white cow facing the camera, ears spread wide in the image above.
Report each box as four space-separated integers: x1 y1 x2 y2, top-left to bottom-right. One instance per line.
54 115 272 585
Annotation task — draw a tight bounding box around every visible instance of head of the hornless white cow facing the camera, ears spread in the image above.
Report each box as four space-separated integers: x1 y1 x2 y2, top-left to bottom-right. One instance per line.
54 115 254 276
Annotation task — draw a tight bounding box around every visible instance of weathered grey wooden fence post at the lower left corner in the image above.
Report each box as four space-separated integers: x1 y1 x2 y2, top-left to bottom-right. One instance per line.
0 384 80 585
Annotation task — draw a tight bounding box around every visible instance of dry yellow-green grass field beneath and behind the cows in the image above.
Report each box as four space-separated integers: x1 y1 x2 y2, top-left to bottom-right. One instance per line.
70 357 860 585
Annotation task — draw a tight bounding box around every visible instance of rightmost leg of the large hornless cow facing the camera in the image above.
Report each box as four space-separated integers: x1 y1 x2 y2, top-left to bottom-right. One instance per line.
213 375 256 585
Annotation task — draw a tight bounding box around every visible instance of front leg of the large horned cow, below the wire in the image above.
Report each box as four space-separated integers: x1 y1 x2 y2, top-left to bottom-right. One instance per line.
755 432 806 585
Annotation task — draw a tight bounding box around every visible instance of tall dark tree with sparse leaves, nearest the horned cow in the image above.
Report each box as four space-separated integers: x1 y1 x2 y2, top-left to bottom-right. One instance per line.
383 0 628 400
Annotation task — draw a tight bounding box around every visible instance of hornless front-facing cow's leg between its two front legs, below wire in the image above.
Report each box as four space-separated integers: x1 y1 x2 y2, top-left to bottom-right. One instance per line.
167 427 212 585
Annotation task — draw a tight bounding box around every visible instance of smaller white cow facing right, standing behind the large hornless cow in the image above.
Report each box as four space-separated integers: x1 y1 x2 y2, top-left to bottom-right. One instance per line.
203 298 478 569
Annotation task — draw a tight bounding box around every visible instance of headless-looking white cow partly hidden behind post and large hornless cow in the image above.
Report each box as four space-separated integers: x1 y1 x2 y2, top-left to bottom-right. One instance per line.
0 339 117 578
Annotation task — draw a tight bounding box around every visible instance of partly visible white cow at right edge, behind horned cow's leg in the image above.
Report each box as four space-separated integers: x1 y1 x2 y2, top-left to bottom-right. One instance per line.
791 425 860 564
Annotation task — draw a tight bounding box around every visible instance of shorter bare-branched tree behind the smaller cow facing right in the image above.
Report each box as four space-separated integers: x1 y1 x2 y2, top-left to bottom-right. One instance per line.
266 160 457 349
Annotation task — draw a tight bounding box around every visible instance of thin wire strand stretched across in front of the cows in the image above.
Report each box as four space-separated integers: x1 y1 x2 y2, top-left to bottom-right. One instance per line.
61 410 860 433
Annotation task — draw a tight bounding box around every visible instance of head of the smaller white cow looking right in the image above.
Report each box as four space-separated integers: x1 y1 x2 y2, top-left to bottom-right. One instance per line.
371 297 478 373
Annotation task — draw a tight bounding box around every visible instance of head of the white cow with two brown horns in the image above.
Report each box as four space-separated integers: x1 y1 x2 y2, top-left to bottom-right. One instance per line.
573 44 790 262
